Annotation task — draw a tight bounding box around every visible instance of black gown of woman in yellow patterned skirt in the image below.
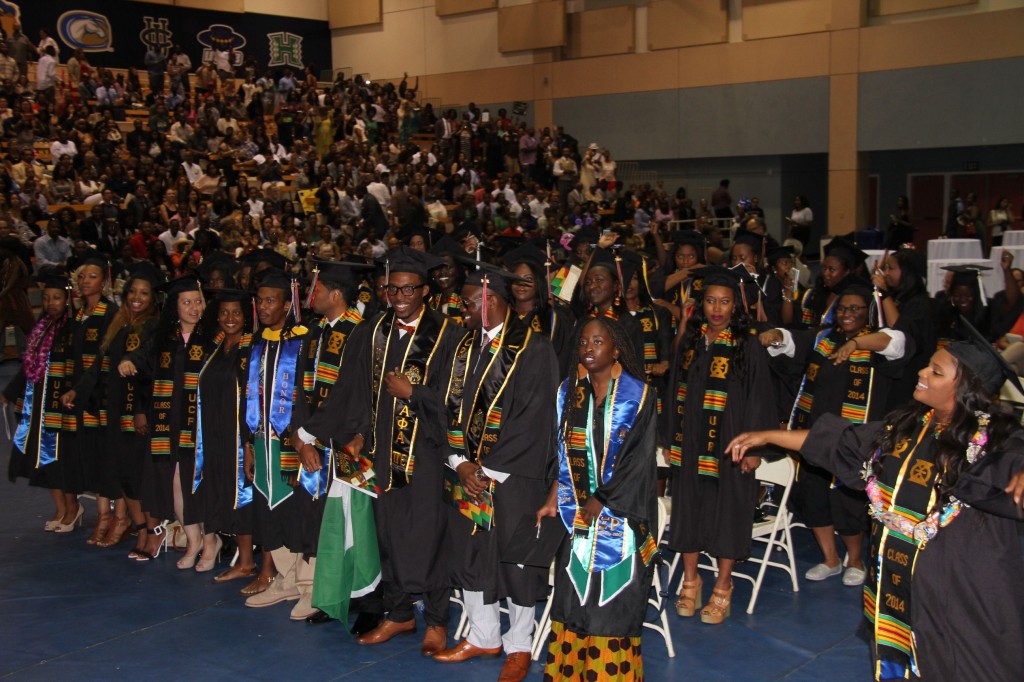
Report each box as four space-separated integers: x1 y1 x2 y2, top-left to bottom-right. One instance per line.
551 391 657 637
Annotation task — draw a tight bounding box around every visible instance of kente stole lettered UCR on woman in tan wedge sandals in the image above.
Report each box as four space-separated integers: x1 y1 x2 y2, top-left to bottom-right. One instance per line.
669 323 736 478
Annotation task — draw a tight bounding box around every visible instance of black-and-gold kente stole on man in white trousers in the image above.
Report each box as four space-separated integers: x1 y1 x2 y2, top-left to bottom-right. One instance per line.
445 309 534 464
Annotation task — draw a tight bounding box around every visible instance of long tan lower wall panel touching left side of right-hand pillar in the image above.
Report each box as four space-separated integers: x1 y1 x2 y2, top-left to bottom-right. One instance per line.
676 33 829 88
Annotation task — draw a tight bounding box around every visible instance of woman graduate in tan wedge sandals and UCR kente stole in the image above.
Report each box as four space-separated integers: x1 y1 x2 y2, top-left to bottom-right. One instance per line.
663 266 778 625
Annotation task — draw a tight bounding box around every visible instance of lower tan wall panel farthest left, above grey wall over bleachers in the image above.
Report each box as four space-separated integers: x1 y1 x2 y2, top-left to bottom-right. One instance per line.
552 51 679 97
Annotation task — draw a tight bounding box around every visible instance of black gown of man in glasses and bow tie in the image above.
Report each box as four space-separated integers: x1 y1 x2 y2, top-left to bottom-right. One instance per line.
303 309 465 594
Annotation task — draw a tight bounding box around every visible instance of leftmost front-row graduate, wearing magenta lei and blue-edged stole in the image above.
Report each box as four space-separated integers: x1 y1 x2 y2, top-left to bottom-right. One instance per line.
3 274 73 531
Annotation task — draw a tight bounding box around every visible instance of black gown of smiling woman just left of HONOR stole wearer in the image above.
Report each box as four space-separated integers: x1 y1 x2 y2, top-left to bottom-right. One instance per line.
199 346 253 535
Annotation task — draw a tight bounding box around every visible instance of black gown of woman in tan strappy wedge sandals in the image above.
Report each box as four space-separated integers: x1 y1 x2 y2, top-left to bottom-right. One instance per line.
663 335 778 559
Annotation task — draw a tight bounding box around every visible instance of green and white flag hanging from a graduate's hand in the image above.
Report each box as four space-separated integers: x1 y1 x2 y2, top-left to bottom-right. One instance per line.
312 479 381 623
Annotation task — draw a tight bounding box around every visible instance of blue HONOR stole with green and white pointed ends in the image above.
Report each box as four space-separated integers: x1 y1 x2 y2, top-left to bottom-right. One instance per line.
246 326 307 509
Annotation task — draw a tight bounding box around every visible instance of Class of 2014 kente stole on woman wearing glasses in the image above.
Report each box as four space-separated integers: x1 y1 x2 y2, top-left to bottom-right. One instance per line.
790 327 874 430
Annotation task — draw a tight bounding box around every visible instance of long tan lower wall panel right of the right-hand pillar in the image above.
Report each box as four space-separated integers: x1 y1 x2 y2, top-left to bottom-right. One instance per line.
860 9 1024 72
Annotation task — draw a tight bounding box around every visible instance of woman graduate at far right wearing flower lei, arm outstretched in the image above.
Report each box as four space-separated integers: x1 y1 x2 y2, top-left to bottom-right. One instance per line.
730 333 1024 682
